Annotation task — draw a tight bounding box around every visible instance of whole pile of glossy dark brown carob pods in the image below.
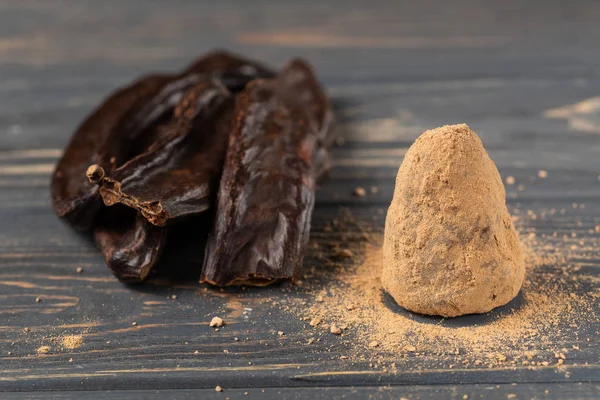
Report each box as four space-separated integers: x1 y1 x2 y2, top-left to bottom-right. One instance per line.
51 51 334 286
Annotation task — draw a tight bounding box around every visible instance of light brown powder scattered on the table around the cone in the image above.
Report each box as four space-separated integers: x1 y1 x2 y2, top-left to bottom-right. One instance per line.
296 203 600 370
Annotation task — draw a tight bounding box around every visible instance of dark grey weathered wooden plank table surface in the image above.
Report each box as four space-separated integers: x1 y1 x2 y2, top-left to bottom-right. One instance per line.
0 0 600 399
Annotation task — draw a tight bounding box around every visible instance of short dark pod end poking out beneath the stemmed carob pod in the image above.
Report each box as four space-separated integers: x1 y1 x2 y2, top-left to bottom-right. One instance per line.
94 207 166 283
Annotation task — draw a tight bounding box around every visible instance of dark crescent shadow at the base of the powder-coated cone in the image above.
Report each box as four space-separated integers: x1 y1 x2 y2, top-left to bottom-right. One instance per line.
381 290 526 328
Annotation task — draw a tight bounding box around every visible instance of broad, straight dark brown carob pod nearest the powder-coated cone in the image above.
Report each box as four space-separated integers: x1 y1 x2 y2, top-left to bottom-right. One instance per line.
201 79 319 286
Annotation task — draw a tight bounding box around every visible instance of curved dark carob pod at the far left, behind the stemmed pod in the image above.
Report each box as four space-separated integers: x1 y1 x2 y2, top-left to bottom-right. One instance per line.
51 51 273 231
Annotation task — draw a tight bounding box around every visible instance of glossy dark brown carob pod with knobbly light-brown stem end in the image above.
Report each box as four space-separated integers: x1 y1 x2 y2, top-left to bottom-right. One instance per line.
89 81 233 226
